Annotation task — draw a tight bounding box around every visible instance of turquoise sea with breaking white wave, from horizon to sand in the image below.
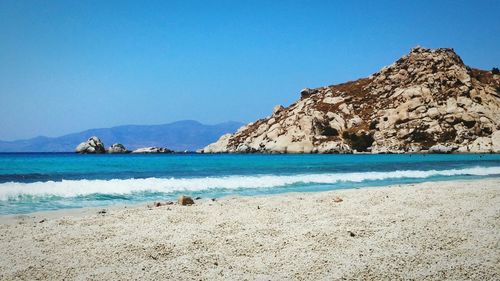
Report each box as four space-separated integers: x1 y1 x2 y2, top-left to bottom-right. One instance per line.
0 154 500 214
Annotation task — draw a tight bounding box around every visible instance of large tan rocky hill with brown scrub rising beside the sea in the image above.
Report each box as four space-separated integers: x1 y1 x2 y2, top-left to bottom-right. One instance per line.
202 47 500 153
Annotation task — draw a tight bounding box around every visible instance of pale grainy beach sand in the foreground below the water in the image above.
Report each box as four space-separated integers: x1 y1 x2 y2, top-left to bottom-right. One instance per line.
0 178 500 280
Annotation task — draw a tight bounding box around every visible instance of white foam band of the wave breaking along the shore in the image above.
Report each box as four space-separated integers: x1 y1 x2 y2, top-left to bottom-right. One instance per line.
0 167 500 201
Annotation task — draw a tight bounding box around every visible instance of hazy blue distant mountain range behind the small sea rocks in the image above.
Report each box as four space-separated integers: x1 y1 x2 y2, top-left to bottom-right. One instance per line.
0 120 243 152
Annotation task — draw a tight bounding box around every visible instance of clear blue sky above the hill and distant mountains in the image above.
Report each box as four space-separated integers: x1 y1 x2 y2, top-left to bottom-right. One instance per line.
0 0 500 140
